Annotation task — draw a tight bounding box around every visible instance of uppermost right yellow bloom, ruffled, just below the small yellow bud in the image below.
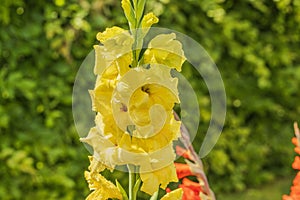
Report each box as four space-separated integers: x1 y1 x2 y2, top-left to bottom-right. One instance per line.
144 33 186 71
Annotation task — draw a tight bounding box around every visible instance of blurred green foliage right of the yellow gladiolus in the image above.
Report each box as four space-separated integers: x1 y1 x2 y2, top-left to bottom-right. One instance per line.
160 0 300 192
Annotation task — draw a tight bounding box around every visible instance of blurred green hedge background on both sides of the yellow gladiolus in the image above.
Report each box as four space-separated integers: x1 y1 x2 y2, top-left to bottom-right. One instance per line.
0 0 300 200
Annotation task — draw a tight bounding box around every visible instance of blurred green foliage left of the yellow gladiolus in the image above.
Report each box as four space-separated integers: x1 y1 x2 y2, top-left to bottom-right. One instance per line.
0 1 113 199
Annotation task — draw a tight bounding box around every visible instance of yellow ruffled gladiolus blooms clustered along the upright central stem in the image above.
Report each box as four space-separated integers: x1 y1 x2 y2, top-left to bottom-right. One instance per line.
81 10 185 199
